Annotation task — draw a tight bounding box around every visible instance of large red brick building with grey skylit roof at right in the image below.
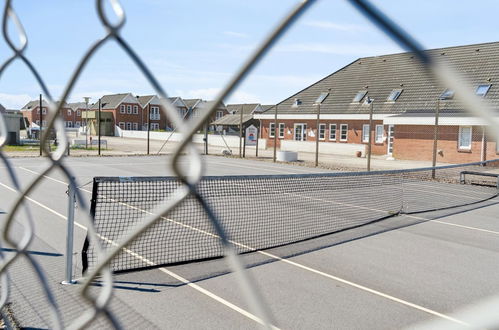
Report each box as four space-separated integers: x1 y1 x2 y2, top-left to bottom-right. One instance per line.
255 42 499 163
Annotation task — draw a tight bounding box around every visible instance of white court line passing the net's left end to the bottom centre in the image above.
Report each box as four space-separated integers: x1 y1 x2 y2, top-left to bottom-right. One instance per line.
0 180 279 329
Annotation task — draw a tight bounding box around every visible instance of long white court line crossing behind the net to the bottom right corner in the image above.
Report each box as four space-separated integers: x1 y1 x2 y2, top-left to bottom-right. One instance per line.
15 170 469 325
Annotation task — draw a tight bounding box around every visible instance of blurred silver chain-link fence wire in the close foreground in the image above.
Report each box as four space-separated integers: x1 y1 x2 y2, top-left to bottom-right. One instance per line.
0 0 499 329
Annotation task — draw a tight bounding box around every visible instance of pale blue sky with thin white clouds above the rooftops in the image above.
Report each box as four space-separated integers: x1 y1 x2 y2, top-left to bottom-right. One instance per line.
0 0 499 109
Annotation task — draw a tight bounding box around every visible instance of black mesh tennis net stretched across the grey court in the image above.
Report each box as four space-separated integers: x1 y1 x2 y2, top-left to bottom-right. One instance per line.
82 160 499 272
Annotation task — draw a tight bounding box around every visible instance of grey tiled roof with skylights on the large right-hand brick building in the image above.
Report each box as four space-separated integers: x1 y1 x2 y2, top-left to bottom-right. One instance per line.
266 42 499 114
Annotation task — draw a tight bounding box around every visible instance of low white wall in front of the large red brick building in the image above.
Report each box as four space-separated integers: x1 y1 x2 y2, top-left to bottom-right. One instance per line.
281 140 365 156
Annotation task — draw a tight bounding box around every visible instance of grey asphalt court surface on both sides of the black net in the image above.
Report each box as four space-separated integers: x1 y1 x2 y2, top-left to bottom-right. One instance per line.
0 157 499 329
